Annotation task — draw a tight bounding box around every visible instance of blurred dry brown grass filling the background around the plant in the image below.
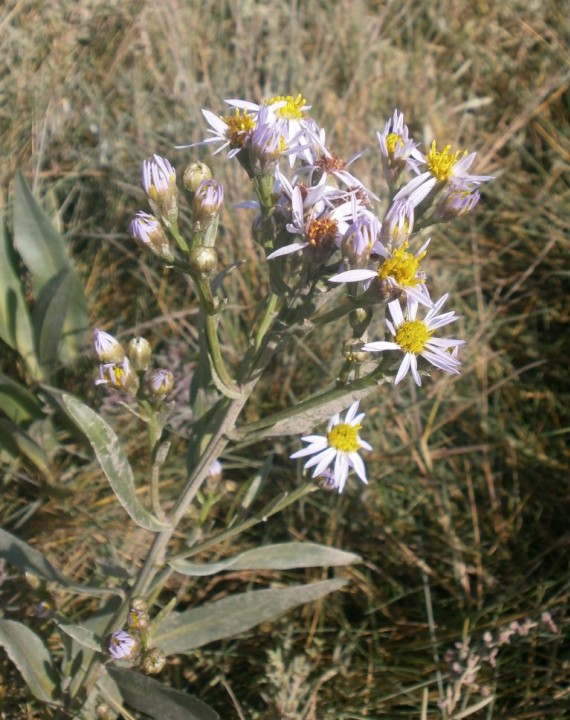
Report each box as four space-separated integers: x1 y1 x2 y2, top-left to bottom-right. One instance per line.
0 0 570 720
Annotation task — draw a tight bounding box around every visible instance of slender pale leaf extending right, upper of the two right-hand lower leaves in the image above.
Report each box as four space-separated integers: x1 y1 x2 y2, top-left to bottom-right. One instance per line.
170 542 361 576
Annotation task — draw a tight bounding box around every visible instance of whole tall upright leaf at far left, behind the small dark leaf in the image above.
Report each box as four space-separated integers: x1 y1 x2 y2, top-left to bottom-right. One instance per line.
14 173 88 362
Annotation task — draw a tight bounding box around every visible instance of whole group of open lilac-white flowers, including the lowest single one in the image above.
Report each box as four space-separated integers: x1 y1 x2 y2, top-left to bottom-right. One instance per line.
181 95 492 492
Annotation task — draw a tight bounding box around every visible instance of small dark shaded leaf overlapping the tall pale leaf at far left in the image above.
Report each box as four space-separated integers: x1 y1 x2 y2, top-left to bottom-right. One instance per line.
32 268 71 372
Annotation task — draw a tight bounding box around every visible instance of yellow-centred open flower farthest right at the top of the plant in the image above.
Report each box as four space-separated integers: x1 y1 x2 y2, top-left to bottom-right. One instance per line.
394 140 493 205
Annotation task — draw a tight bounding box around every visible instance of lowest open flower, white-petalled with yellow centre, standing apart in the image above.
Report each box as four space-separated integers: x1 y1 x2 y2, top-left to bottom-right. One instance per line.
291 401 372 493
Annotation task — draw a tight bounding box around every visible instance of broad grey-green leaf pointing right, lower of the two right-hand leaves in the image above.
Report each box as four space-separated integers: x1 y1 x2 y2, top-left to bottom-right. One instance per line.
152 579 348 655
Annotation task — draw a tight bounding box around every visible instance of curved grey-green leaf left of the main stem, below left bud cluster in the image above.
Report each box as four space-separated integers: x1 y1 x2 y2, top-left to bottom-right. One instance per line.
62 395 169 532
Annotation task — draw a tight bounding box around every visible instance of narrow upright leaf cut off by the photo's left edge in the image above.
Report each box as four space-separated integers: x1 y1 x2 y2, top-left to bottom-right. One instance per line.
0 216 42 380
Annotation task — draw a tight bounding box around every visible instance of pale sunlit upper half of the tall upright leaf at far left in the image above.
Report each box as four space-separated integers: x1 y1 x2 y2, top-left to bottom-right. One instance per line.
14 172 69 297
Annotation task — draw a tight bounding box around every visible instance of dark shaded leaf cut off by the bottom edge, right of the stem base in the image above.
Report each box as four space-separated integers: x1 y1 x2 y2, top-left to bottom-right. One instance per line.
107 666 220 720
